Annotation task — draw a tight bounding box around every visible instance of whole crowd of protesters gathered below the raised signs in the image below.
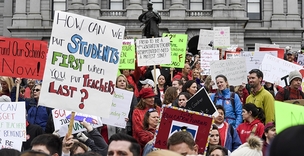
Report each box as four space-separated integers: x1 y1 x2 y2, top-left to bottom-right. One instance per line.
0 46 304 156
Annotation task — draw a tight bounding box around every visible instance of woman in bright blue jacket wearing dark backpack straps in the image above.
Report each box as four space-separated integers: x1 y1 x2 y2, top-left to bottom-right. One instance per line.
210 75 243 128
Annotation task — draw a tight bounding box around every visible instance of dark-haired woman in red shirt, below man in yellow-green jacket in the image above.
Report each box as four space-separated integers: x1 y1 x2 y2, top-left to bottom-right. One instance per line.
236 103 265 143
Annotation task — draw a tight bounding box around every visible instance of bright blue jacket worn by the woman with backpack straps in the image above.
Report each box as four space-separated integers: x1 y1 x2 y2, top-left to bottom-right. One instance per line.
210 88 243 128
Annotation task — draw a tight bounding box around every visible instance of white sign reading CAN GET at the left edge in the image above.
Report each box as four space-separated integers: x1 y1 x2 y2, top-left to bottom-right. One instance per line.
0 102 26 150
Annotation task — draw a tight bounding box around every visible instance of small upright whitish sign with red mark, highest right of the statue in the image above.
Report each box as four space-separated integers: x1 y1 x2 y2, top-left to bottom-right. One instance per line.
213 27 230 48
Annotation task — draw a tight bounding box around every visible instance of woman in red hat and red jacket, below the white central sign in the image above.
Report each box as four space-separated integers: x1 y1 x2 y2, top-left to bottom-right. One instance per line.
132 88 160 143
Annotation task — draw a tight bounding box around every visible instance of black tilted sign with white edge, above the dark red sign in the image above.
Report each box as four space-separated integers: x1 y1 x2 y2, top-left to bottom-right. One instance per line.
185 87 218 117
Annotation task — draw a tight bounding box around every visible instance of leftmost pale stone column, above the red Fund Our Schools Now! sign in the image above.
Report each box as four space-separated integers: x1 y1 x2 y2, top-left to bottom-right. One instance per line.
13 0 27 27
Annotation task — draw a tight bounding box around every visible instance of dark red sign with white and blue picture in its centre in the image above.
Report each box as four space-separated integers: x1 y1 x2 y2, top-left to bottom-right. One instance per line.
154 106 213 153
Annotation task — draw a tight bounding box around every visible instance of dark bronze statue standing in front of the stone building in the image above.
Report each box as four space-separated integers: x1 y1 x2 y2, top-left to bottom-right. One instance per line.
138 1 161 38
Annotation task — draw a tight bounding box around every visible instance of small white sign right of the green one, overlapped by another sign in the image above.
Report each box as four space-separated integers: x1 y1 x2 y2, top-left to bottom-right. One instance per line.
197 29 214 50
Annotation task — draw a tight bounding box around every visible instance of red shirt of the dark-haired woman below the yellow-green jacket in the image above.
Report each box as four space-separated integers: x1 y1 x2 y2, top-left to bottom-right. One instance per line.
236 119 264 143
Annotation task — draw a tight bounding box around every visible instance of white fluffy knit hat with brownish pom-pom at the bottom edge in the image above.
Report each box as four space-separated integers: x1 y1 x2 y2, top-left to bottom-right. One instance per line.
230 135 263 156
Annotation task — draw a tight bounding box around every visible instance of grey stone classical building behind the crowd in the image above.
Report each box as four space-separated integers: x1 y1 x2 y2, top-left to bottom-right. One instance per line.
0 0 304 51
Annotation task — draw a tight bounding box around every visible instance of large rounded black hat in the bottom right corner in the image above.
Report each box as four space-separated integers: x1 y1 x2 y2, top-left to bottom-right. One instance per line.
269 125 304 156
